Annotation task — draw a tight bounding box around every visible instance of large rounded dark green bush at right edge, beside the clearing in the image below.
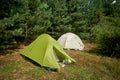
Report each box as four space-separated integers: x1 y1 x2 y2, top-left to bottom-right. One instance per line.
93 26 120 57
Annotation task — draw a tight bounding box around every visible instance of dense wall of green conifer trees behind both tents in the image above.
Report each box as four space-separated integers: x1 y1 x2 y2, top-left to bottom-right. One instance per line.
0 0 120 49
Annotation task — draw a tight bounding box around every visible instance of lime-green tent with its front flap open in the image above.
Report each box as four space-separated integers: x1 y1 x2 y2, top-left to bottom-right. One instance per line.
21 34 75 68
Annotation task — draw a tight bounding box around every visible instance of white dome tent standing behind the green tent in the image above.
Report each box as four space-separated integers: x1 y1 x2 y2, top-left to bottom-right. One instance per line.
58 33 84 50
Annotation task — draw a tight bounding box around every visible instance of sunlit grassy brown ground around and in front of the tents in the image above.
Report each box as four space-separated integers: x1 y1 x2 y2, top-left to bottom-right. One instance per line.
0 41 120 80
